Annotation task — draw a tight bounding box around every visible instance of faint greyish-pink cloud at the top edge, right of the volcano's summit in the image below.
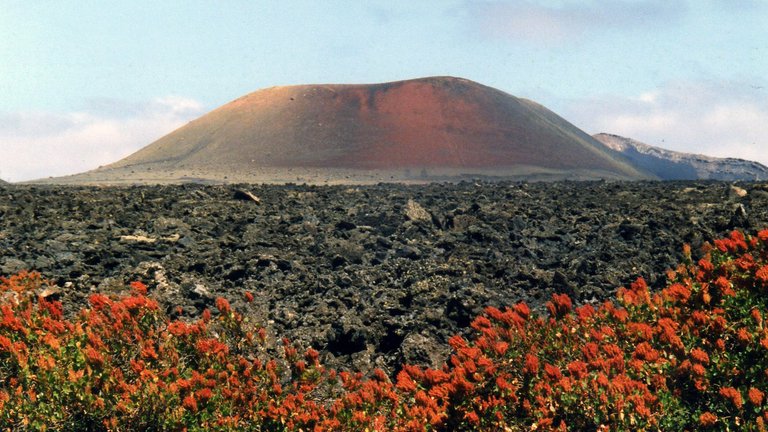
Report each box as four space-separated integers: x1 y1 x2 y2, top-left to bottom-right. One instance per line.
467 0 686 44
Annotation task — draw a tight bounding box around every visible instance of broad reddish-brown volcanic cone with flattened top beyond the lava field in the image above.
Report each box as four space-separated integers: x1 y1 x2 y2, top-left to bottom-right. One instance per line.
107 77 643 178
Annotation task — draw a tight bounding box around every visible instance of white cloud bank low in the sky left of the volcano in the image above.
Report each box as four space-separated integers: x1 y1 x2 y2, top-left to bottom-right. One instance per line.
0 96 203 181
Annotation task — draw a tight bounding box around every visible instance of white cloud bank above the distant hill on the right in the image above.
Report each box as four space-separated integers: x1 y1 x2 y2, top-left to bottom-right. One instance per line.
563 82 768 165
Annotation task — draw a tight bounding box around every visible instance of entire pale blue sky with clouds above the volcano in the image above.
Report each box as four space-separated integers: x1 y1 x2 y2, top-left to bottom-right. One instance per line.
0 0 768 181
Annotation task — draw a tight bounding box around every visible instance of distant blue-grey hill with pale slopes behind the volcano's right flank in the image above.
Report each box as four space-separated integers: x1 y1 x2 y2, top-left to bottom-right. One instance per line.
594 133 768 181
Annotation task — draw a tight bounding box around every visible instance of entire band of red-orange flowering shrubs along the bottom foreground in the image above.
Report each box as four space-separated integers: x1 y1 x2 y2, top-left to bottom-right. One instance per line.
0 230 768 431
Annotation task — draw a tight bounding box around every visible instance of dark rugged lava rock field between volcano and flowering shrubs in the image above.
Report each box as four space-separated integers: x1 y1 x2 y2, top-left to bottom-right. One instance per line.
0 182 768 372
